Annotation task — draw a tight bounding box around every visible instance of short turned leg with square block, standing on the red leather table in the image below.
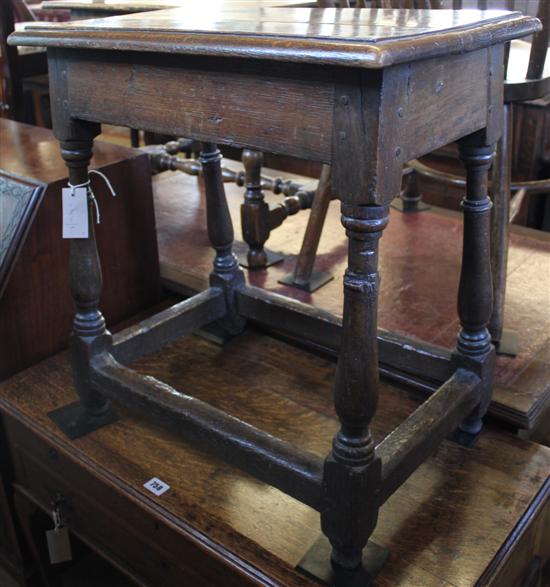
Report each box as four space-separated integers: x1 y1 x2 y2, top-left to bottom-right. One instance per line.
241 149 269 269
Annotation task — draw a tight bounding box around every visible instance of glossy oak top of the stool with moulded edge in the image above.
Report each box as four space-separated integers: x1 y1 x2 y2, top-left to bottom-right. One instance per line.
10 7 540 68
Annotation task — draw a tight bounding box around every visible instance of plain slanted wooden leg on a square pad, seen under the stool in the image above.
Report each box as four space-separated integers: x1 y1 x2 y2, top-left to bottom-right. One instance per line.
279 165 334 292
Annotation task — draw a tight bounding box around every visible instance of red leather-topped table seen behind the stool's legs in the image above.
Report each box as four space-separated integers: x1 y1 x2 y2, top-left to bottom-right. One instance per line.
154 168 550 429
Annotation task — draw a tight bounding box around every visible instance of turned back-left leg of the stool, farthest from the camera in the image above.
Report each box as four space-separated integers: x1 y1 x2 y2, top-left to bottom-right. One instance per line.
199 143 244 334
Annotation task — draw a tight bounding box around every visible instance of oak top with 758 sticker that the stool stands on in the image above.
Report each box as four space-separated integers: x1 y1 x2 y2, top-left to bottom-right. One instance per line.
0 331 550 587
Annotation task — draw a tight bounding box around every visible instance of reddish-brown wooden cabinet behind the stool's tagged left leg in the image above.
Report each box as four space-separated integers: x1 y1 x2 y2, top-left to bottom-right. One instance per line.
0 119 160 584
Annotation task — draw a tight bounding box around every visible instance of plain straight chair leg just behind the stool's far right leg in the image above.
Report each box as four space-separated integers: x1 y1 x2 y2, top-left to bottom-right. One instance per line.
489 104 518 356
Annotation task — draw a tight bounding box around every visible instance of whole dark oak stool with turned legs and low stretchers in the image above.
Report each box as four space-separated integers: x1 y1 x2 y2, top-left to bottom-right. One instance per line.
8 8 539 587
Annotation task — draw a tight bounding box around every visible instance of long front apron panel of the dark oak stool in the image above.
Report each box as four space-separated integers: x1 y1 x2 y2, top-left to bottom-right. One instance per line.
62 51 334 161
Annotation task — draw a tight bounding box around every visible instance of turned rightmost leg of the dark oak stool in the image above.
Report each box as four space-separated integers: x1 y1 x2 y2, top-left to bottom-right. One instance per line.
456 135 494 434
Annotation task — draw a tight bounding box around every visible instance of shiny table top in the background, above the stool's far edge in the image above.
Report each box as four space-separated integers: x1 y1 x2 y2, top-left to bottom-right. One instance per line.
40 0 315 15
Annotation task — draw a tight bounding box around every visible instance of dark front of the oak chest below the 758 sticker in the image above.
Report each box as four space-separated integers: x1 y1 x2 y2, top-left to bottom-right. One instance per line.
7 421 266 587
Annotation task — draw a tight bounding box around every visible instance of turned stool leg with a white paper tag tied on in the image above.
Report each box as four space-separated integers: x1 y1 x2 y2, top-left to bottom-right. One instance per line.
61 140 111 419
